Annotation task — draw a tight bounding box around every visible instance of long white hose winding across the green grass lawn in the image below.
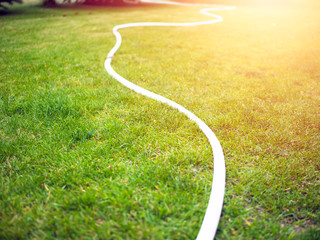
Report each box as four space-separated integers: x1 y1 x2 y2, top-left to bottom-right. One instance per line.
105 0 235 240
